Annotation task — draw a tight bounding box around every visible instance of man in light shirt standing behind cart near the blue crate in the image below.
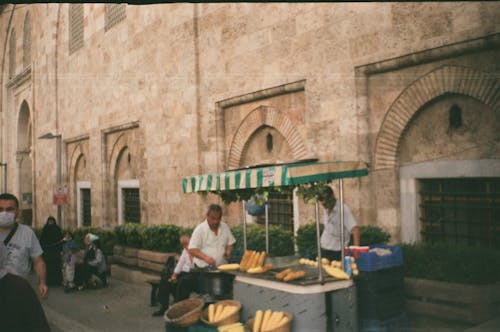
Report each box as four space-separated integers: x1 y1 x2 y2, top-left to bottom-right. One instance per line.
319 186 360 261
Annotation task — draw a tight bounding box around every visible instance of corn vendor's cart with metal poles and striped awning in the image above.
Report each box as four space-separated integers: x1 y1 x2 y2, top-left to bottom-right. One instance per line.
182 160 368 331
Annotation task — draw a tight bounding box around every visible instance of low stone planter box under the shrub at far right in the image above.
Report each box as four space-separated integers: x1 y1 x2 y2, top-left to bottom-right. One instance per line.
405 278 500 324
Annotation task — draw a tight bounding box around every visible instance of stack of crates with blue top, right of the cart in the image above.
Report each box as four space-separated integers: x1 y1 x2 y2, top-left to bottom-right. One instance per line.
356 245 408 332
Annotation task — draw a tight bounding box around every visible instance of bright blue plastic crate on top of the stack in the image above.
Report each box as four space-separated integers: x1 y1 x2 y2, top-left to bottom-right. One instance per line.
356 244 403 272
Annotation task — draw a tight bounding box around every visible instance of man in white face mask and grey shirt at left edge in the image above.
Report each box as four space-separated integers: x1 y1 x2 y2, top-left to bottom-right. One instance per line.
0 193 48 298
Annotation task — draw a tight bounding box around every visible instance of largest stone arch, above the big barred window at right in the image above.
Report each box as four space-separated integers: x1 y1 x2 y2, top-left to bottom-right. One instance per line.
374 65 500 170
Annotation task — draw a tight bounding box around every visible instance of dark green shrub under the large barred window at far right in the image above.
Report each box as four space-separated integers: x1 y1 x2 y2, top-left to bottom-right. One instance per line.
401 243 500 285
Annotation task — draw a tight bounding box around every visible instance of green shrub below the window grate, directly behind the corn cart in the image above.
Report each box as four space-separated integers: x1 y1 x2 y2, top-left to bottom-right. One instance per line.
231 224 295 257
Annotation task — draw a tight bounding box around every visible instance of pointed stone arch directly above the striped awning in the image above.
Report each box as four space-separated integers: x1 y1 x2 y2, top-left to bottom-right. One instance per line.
228 106 307 169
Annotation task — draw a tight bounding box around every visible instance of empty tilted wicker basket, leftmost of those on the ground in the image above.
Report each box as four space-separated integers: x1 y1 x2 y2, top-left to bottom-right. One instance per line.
163 298 205 327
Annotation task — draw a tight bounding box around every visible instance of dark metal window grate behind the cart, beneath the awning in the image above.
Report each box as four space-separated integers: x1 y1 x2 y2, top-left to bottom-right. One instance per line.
257 193 293 232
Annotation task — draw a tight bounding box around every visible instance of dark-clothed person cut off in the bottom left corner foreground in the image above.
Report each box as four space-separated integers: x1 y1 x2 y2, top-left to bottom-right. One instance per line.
0 242 50 332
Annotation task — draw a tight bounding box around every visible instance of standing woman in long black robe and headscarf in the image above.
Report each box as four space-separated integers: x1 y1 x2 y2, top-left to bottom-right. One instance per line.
40 216 63 286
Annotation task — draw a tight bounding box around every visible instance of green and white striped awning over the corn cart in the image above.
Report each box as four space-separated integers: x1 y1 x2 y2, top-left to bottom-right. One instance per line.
182 161 368 193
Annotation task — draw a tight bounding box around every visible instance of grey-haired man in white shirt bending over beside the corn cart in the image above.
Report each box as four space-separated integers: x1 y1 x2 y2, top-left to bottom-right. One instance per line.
189 204 236 268
